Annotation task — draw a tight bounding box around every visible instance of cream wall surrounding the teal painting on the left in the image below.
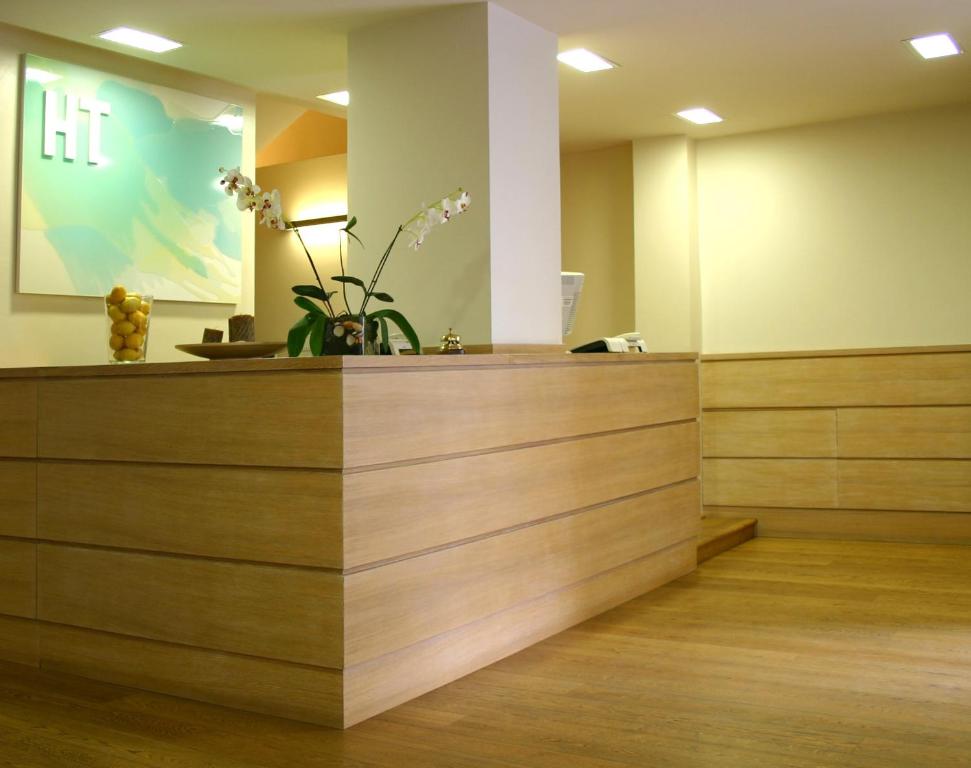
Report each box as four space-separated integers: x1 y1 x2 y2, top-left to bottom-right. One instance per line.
0 24 254 367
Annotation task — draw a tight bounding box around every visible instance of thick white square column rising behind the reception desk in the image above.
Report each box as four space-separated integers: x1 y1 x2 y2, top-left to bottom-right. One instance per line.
348 3 560 345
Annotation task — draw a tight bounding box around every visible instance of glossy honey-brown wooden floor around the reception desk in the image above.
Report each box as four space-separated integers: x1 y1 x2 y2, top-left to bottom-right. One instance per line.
0 539 971 768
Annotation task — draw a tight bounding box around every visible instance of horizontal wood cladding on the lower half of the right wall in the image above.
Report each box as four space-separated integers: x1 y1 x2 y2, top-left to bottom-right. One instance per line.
701 347 971 543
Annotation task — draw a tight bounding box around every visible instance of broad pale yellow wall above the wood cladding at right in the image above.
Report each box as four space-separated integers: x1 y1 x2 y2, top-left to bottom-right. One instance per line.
697 104 971 353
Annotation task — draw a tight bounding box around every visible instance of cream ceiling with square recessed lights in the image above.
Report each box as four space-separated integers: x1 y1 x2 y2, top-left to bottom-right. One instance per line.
0 0 971 150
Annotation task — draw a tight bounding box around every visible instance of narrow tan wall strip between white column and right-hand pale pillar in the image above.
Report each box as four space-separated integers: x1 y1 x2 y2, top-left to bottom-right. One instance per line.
560 144 635 347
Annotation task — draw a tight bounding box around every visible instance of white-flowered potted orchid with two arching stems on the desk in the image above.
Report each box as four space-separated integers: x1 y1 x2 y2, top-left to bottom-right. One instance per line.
219 168 471 357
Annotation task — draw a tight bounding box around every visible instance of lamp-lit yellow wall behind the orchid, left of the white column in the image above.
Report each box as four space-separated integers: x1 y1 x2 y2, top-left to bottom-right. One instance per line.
256 155 348 341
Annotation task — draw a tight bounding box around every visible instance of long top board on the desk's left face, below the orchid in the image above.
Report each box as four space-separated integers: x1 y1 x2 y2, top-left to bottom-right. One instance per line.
38 370 341 467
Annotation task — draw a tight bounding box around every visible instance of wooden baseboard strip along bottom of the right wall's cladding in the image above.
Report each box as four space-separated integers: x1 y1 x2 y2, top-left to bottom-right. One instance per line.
705 507 971 545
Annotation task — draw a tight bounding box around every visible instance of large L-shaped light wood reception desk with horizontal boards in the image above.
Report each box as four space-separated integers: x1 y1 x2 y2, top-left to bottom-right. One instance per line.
0 354 699 727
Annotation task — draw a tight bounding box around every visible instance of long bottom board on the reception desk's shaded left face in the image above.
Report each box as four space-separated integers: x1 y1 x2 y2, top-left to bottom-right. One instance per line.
40 624 342 728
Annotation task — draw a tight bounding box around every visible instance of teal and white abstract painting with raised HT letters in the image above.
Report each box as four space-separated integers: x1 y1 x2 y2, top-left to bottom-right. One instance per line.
18 55 248 303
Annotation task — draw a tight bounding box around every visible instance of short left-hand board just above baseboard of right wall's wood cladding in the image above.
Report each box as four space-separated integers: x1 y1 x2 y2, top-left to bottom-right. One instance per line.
702 459 837 508
